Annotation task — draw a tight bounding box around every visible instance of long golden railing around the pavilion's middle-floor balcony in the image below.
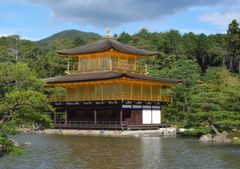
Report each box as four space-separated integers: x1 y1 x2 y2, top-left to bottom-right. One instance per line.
49 94 172 103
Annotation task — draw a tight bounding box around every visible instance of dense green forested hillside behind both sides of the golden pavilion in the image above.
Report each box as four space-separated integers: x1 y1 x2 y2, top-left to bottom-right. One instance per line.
0 20 240 135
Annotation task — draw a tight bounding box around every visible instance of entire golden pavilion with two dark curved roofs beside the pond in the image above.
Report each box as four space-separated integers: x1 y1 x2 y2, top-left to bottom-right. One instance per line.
44 36 181 130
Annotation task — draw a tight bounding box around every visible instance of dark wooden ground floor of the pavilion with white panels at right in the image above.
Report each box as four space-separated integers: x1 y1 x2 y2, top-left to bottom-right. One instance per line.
52 101 168 130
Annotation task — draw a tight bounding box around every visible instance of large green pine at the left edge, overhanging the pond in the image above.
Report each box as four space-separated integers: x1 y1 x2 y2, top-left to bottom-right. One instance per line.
0 63 53 156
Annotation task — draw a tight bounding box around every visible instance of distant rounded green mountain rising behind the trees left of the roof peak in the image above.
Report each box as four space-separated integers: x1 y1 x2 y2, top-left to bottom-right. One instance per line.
35 30 101 50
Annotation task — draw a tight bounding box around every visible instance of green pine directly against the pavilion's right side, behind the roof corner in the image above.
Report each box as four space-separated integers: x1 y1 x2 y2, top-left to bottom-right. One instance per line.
153 59 200 125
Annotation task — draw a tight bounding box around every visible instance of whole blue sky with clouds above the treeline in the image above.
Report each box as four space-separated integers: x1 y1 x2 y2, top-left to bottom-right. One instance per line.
0 0 240 40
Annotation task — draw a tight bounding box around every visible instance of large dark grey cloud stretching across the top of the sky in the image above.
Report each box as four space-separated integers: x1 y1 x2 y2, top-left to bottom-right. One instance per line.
21 0 232 27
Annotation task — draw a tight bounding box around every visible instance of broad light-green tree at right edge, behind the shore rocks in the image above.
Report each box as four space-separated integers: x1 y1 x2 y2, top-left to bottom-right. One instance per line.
188 68 240 131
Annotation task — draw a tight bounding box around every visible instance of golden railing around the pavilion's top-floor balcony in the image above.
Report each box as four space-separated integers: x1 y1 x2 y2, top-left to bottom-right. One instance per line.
68 60 147 75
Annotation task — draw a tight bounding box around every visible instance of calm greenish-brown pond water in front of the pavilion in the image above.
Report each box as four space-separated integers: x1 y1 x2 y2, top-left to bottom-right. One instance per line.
0 135 240 169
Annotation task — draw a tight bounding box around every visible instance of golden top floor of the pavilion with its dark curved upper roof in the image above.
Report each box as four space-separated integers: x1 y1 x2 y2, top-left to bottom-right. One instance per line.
58 36 156 75
